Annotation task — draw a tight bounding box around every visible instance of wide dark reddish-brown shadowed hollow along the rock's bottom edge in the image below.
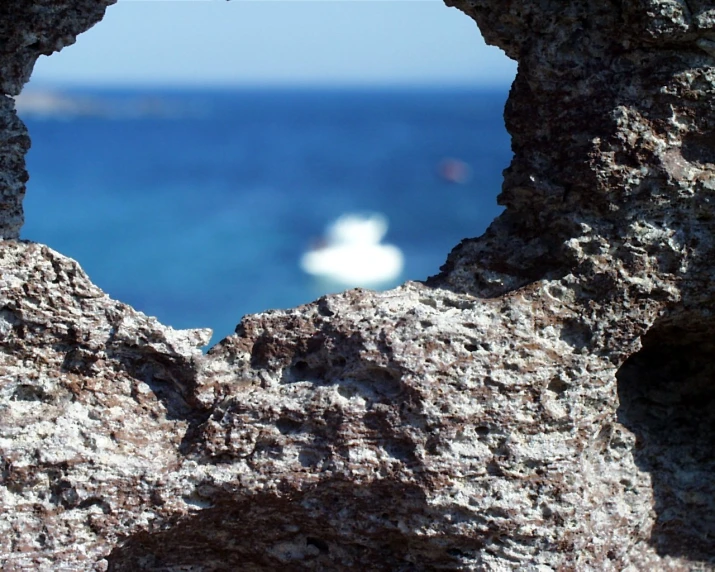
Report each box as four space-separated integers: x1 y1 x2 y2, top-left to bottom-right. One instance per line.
108 481 483 572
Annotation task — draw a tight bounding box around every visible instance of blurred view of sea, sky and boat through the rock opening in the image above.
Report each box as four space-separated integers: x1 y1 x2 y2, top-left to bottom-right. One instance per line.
18 0 515 342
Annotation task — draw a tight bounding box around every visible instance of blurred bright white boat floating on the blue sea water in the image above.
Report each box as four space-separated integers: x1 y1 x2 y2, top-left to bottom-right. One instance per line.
300 214 404 287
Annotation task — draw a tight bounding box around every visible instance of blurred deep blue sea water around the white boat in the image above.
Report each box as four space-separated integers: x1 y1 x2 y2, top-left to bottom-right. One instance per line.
21 89 511 342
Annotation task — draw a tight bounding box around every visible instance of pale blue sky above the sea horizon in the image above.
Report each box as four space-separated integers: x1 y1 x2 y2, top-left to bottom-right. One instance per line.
32 0 516 86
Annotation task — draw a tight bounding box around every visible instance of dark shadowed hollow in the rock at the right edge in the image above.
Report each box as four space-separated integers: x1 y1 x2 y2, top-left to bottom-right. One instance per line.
617 327 715 562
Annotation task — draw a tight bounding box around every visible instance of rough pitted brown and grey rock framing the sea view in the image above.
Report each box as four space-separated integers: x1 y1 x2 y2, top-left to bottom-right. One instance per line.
0 0 715 572
